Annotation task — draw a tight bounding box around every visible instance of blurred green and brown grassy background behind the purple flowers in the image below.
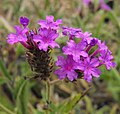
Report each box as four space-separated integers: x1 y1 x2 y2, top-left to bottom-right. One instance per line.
0 0 120 114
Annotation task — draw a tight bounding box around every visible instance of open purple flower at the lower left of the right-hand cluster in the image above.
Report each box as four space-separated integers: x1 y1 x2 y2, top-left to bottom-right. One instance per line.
55 56 78 81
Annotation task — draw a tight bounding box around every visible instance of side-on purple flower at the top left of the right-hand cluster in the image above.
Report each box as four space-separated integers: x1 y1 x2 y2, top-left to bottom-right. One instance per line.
62 26 81 40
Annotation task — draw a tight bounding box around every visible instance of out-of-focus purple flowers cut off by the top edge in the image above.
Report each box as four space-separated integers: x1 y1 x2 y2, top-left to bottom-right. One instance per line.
83 0 111 11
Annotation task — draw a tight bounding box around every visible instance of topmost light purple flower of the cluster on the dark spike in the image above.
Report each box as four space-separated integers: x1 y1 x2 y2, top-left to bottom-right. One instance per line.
38 16 62 30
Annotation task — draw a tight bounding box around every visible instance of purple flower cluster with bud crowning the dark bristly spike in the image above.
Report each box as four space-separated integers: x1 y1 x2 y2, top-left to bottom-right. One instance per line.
7 16 62 51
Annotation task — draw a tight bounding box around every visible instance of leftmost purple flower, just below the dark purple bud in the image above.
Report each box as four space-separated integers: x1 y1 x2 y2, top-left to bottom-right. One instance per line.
7 25 28 45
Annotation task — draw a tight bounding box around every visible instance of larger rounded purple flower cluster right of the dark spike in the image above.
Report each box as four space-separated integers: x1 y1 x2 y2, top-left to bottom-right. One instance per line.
55 27 115 82
